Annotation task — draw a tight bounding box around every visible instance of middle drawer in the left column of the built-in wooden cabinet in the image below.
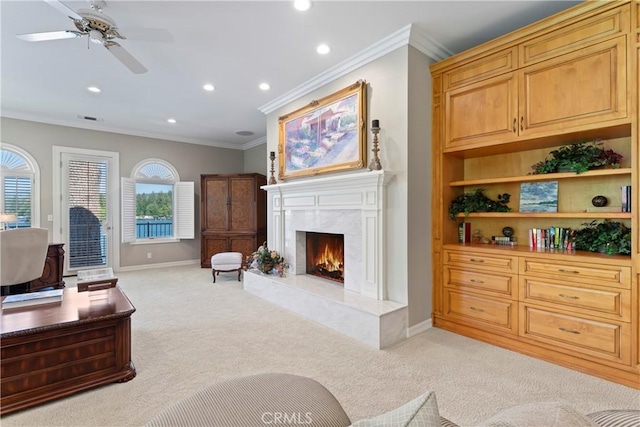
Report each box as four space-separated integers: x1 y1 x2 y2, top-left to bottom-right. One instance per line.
444 266 518 299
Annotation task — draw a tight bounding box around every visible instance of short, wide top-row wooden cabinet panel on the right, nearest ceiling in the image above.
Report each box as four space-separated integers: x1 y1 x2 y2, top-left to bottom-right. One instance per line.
519 5 630 66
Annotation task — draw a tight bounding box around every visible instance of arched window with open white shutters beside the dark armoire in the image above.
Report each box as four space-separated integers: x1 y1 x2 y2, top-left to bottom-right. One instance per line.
122 159 195 242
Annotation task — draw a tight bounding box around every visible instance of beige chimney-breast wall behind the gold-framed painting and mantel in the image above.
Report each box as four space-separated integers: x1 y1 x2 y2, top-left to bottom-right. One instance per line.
267 46 431 326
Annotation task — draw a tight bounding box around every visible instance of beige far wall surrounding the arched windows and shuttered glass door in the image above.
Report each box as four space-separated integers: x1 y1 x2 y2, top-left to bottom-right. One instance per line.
0 118 245 267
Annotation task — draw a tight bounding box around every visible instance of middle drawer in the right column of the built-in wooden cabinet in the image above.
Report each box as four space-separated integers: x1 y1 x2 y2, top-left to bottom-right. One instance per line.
520 277 631 322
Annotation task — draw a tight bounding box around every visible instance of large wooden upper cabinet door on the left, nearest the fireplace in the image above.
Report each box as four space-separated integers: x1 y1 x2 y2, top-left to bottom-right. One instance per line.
444 73 518 151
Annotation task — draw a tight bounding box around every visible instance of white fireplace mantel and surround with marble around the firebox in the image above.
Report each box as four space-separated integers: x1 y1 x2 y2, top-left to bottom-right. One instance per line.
262 170 393 300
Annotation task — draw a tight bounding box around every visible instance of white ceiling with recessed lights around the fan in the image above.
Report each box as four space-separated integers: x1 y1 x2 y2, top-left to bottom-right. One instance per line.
0 0 580 149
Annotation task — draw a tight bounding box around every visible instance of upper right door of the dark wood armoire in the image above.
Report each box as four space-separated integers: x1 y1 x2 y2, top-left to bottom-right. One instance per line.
229 177 256 232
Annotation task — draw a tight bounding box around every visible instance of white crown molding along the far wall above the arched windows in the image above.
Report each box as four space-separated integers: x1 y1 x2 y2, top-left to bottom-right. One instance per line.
0 110 248 150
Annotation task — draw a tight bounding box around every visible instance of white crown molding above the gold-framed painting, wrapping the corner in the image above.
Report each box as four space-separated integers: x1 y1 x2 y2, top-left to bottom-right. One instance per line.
258 24 453 114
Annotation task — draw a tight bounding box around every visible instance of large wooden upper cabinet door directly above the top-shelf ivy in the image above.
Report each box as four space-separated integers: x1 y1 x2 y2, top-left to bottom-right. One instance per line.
518 36 627 136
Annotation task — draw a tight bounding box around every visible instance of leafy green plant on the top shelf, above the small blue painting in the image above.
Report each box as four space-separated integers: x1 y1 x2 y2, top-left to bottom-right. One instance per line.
531 141 622 175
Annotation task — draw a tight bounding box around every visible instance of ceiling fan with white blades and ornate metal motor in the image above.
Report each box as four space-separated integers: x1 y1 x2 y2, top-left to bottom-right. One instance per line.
16 0 173 74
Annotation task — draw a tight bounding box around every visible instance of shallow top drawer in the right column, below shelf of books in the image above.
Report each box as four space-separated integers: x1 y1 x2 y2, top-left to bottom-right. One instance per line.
520 258 631 289
